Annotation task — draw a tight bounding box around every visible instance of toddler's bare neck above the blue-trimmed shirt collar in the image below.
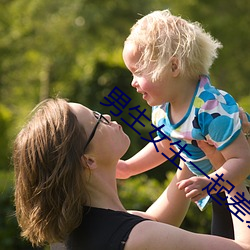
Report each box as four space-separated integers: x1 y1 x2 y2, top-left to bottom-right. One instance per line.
169 76 198 124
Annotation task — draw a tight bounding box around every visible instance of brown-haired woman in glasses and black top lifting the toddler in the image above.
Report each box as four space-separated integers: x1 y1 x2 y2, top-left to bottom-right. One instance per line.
13 99 250 250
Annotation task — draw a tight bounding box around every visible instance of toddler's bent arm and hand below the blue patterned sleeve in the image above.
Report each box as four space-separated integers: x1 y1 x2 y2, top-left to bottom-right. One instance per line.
178 133 250 201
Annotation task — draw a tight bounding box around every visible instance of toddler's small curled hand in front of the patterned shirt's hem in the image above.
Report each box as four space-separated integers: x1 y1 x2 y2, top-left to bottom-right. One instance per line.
177 176 210 202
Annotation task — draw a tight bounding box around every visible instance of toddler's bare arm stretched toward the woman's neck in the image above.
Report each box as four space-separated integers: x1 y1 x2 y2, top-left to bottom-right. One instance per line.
116 140 174 179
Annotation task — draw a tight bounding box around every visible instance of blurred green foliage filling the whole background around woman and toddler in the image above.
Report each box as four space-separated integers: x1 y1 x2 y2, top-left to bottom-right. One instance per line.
0 0 250 249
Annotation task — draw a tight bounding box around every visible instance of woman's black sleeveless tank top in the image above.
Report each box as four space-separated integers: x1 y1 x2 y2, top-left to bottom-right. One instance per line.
66 207 146 250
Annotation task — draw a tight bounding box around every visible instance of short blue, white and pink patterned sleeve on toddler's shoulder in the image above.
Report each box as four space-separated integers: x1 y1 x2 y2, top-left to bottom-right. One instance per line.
198 90 241 150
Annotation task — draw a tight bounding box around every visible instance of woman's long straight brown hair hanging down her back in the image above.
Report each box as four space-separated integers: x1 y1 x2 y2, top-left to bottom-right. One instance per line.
13 99 87 246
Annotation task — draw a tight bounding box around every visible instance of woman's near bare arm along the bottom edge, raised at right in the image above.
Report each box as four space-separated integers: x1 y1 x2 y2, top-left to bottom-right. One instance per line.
125 183 250 250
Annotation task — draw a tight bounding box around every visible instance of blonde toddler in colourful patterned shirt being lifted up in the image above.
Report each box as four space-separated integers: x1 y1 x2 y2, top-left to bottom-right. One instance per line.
117 10 250 238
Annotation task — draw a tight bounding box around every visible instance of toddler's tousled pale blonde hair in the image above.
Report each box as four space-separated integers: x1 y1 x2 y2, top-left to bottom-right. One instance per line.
125 10 222 81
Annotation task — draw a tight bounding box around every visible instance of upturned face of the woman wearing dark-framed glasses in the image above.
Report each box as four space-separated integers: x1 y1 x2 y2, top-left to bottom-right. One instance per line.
69 103 130 160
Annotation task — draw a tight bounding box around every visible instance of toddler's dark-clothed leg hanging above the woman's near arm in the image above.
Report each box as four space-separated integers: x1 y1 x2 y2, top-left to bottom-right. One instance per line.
211 192 234 239
